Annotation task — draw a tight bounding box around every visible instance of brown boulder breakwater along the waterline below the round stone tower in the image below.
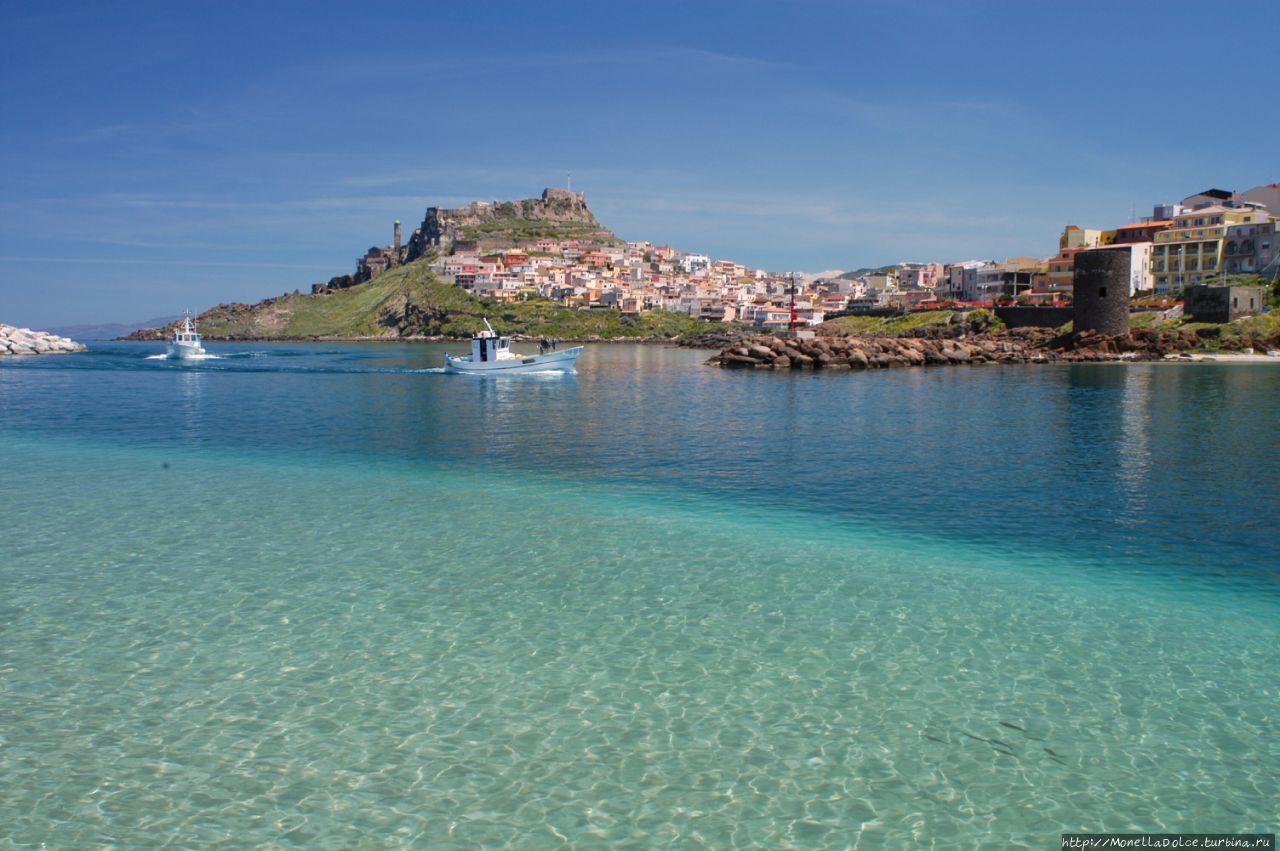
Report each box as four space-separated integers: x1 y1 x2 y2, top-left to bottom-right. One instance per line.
708 328 1201 370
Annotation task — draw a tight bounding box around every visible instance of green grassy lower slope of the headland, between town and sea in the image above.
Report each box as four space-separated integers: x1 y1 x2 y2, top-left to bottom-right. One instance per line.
129 257 712 340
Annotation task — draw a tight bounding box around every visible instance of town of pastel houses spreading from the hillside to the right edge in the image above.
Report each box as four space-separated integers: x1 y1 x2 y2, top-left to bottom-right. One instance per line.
337 183 1280 329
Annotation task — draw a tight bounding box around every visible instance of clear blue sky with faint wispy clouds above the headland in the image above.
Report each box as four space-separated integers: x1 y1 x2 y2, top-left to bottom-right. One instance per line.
0 0 1280 328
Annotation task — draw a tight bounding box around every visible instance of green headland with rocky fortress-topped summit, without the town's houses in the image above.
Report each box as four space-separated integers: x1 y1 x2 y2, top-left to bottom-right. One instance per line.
123 188 705 342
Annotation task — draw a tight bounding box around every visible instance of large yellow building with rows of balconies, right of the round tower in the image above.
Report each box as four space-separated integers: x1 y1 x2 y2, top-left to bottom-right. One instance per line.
1151 206 1270 293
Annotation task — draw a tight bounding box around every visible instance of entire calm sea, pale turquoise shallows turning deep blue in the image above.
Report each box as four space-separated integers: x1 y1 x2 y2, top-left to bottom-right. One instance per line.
0 344 1280 847
